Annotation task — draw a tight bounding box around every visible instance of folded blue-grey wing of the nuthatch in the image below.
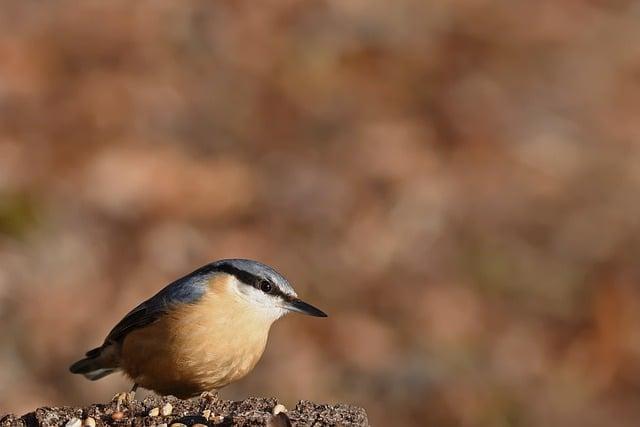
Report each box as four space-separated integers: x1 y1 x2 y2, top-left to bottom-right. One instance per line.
105 269 210 344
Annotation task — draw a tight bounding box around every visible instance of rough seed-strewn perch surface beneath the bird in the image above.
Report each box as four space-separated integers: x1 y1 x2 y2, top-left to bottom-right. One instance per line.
0 397 369 427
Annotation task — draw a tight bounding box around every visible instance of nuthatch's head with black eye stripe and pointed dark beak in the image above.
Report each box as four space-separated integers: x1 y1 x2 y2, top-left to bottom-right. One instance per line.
208 259 327 320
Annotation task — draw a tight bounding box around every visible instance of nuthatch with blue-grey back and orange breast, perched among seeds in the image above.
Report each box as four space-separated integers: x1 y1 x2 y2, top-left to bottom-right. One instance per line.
69 259 327 398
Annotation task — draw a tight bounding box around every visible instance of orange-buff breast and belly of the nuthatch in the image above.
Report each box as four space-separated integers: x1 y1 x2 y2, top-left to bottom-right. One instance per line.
120 280 271 398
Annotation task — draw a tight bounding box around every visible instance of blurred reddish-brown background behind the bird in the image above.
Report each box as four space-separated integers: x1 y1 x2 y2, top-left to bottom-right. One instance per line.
0 0 640 426
